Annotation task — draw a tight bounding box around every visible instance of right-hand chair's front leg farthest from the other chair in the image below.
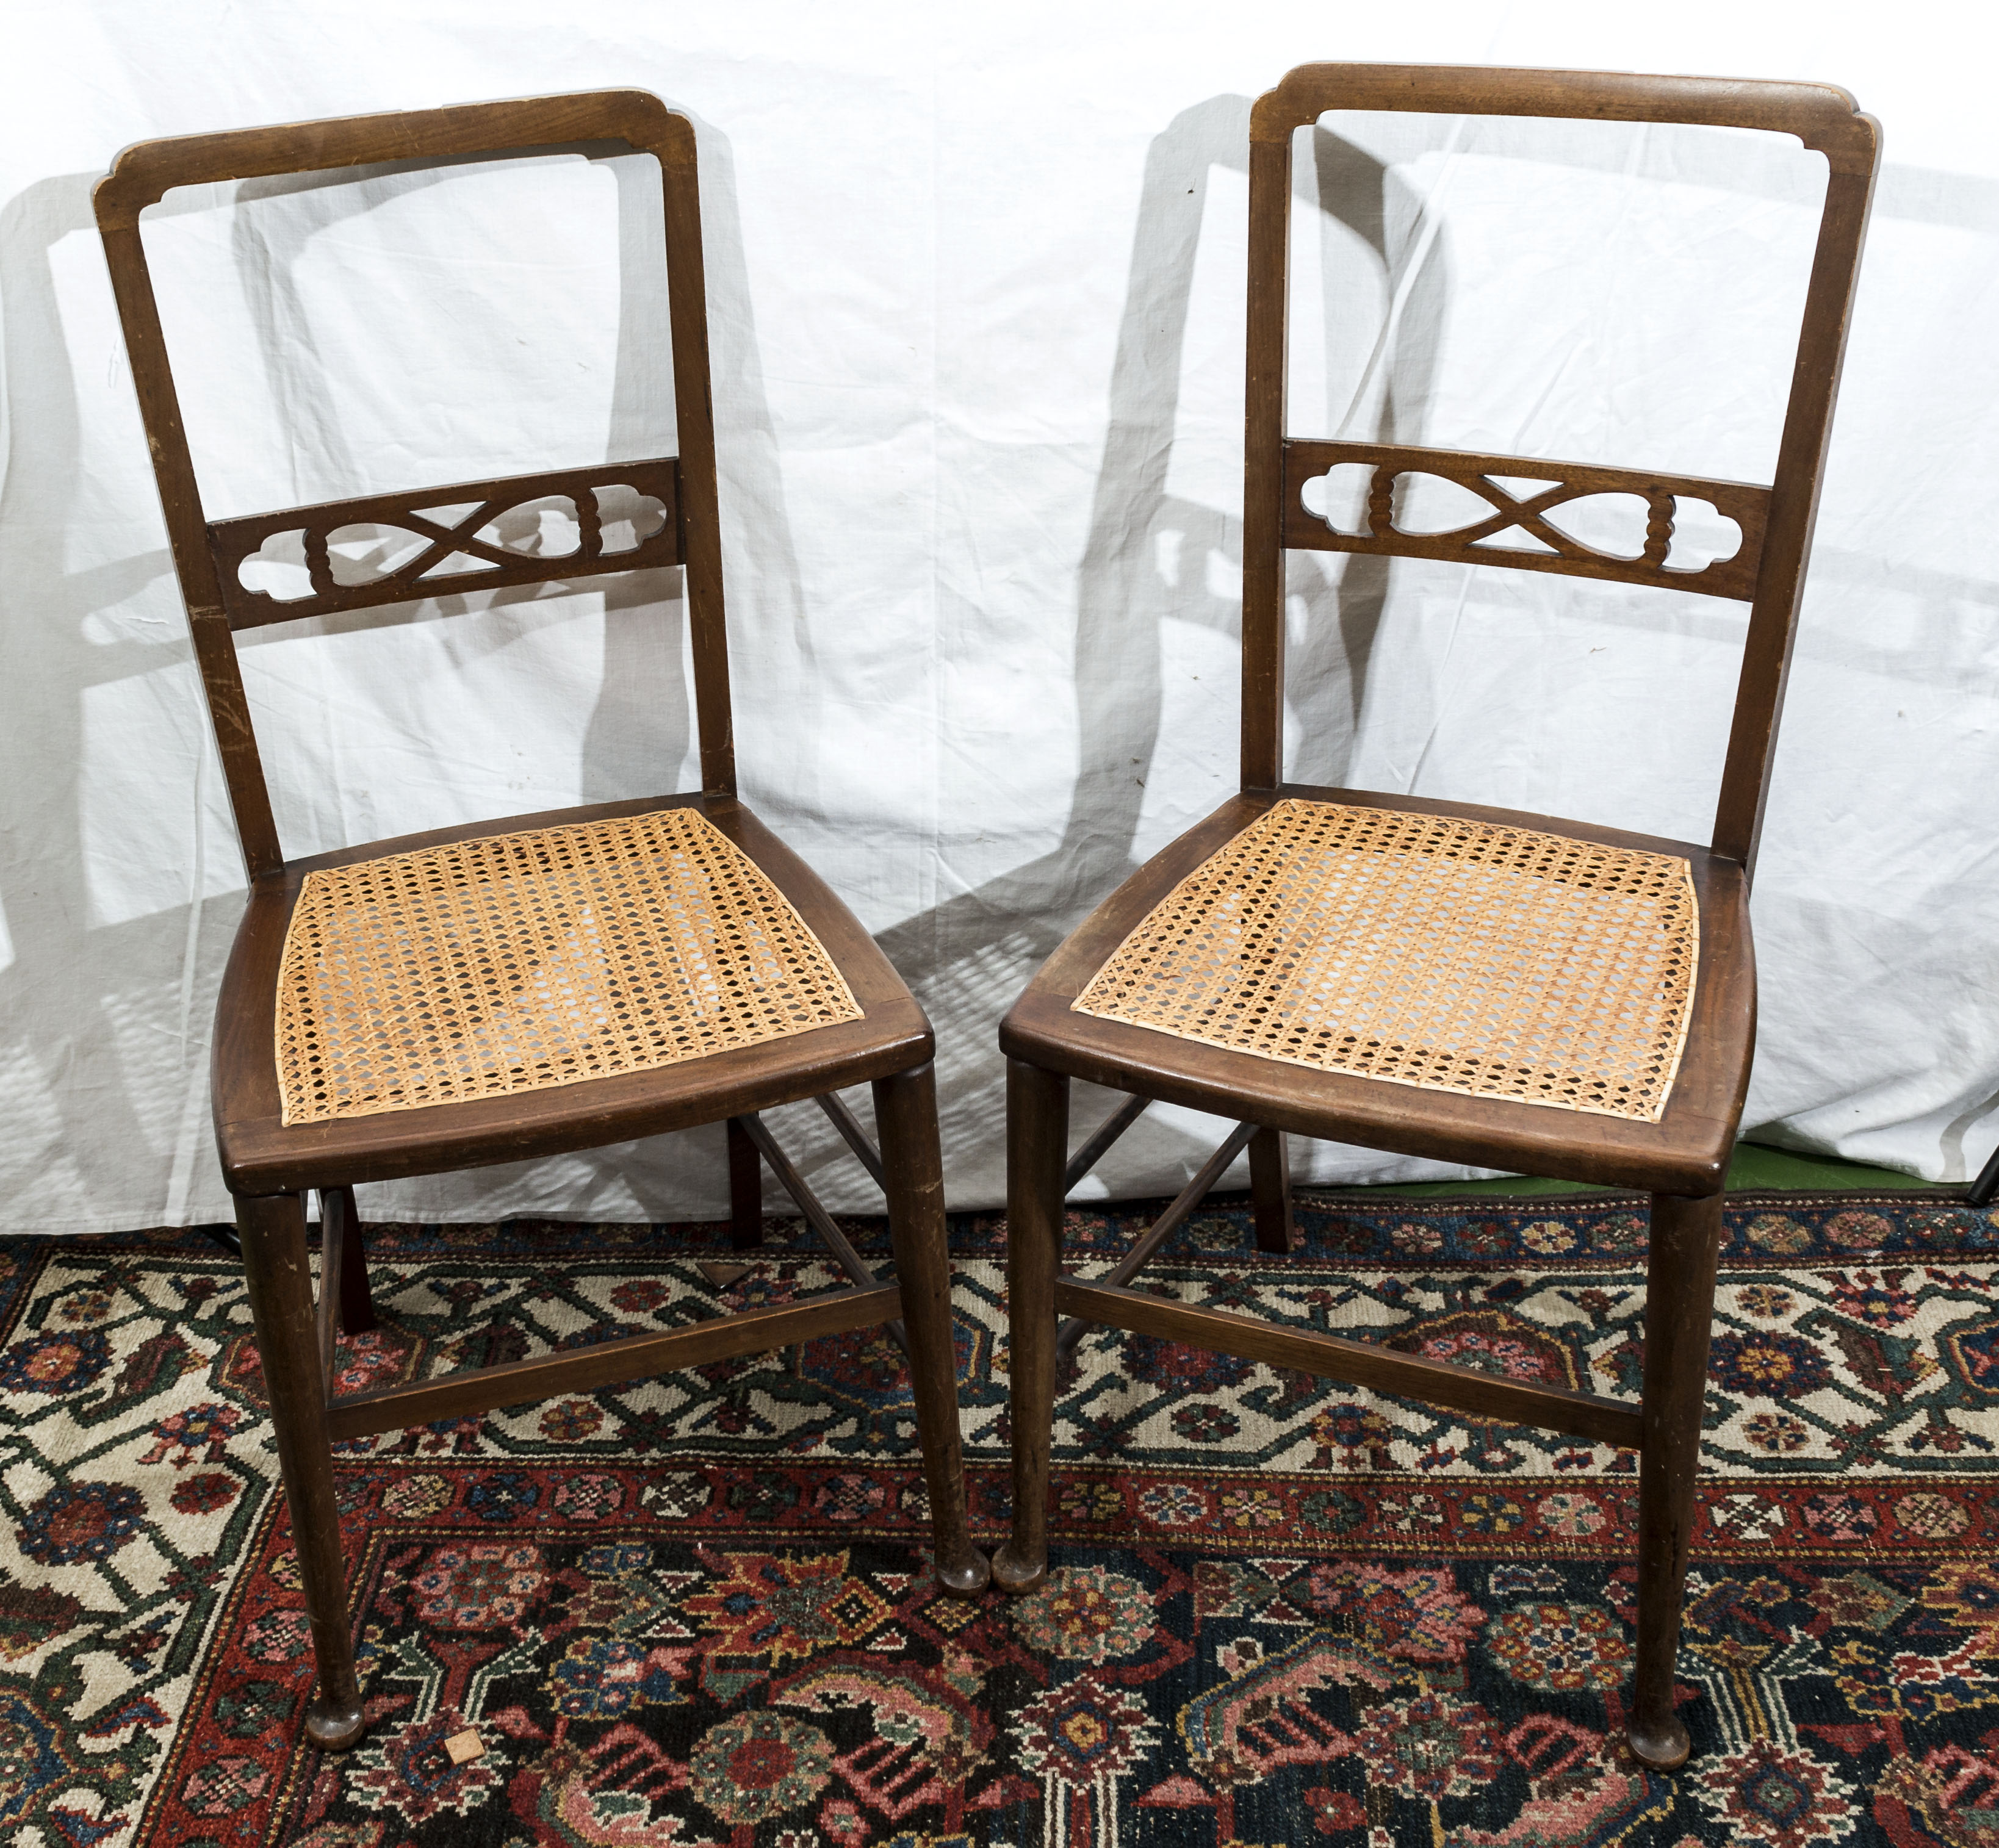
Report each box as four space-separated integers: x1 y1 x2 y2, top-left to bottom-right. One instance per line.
1627 1193 1723 1770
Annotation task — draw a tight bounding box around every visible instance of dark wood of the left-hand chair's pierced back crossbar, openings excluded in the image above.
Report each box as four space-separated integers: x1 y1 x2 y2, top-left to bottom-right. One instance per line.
208 456 680 629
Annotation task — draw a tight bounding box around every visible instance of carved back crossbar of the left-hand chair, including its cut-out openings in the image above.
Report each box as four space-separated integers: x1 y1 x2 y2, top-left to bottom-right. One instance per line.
208 456 682 629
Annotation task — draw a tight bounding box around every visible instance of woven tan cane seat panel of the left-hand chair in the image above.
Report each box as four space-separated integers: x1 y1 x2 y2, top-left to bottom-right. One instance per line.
276 807 862 1123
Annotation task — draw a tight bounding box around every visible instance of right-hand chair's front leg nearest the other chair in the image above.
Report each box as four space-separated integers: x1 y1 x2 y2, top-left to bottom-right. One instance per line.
993 1059 1070 1592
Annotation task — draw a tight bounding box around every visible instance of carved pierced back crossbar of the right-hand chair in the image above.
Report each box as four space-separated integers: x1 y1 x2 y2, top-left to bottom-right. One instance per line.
1283 442 1769 602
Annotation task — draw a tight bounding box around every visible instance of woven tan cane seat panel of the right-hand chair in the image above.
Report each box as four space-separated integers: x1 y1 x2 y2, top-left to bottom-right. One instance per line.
1073 799 1699 1123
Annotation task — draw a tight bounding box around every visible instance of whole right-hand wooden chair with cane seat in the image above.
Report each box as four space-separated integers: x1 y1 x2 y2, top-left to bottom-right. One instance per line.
993 64 1879 1768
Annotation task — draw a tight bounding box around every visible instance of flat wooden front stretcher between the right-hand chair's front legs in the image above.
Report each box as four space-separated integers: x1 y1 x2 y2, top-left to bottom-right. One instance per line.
1056 1276 1639 1450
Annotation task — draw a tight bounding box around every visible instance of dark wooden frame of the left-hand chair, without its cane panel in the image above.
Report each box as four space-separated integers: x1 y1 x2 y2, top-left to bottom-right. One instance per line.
96 90 985 1750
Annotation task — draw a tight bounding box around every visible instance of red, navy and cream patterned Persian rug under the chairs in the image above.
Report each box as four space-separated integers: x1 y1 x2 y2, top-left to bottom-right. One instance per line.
0 1195 1999 1848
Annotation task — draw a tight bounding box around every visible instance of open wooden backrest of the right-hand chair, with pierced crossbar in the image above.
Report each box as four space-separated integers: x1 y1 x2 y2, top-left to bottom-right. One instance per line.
1241 64 1881 869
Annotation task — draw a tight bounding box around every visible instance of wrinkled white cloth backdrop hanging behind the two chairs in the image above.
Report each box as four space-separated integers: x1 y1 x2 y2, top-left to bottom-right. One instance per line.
0 0 1999 1231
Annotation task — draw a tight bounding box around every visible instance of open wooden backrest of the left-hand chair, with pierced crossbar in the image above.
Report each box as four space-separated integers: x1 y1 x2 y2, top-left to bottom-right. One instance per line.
94 90 736 879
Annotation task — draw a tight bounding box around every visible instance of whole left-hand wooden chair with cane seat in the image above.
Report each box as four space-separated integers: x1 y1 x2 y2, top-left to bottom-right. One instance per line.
96 90 987 1750
